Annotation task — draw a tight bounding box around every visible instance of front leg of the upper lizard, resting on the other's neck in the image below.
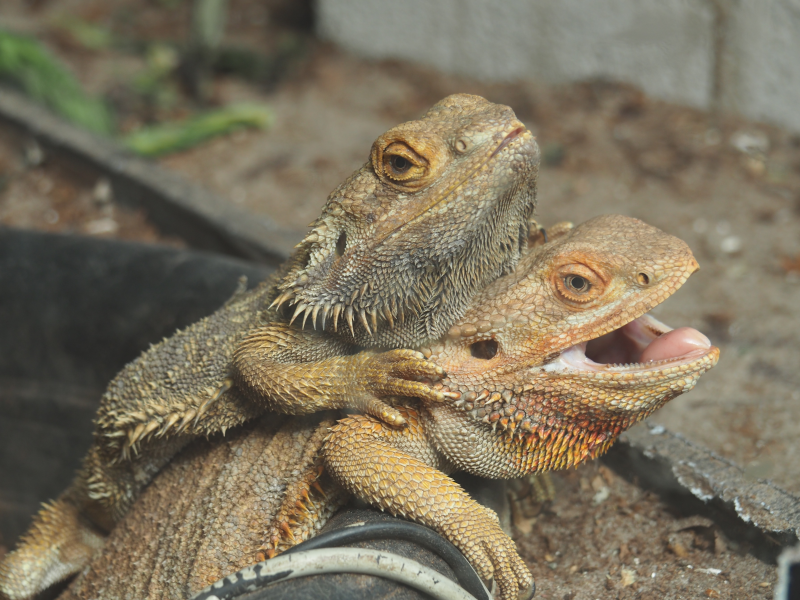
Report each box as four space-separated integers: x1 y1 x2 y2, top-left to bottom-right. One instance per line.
232 322 445 425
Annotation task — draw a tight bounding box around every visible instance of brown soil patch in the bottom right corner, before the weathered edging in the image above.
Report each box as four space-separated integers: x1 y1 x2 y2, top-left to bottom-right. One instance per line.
514 462 776 600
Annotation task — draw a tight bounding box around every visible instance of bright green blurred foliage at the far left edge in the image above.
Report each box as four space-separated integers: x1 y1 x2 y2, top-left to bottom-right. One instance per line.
0 30 113 135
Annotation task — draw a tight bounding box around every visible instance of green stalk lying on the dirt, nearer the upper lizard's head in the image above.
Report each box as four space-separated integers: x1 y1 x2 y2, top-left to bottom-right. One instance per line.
122 104 272 156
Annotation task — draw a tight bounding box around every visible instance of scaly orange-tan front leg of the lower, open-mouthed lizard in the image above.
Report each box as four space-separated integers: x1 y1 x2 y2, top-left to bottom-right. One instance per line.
322 407 533 600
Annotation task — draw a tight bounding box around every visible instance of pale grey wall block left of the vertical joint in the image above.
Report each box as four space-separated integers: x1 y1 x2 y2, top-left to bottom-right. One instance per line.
318 0 713 107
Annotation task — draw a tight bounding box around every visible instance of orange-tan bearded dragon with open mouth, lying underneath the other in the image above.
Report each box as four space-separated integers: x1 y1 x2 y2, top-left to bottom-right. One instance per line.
48 216 719 600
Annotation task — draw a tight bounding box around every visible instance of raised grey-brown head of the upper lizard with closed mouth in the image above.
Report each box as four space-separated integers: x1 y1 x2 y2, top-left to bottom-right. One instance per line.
276 94 539 346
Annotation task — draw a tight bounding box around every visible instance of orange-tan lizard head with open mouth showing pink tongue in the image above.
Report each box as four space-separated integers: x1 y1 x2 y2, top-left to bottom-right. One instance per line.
424 216 719 476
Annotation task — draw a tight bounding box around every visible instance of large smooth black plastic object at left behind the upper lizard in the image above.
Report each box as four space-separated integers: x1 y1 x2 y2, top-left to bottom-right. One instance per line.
0 227 272 547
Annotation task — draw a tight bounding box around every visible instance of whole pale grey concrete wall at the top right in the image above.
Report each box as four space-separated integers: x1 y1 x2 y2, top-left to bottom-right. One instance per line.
317 0 800 131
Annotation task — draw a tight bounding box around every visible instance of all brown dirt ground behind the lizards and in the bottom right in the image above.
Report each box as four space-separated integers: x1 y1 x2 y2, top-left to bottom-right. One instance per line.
0 0 800 600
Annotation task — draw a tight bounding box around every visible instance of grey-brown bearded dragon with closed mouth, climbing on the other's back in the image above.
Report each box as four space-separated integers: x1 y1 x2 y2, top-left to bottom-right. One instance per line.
0 94 539 598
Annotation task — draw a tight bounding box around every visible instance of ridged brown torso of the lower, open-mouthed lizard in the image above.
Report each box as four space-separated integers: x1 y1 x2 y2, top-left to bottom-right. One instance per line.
61 415 349 600
